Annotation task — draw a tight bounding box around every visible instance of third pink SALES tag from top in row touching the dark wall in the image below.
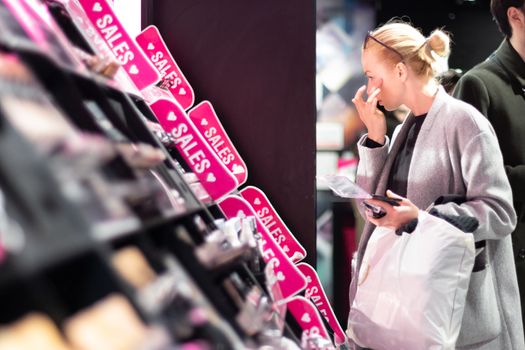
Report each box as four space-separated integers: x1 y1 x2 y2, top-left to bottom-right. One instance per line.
240 186 306 263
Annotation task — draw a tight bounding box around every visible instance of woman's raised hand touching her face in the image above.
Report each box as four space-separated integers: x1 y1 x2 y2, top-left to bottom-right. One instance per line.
352 85 386 145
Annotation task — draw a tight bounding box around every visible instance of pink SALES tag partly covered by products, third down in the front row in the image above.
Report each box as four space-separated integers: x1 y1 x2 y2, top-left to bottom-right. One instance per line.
219 196 306 299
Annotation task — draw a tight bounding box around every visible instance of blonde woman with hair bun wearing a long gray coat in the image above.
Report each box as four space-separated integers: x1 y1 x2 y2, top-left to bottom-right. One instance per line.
350 22 525 350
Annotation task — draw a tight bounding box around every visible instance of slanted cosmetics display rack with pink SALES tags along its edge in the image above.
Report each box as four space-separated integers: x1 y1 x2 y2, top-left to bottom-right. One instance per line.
0 0 346 350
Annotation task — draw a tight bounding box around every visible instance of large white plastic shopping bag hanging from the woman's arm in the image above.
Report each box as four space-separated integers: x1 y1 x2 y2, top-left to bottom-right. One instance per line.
347 211 475 350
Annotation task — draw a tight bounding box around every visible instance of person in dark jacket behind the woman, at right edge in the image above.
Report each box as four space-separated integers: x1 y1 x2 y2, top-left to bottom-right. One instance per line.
453 0 525 330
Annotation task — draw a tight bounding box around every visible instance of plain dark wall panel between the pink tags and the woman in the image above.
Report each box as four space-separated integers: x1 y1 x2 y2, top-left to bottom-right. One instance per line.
148 0 315 264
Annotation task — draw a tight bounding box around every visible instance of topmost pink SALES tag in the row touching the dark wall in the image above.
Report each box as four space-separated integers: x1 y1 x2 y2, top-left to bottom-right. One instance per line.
135 26 195 109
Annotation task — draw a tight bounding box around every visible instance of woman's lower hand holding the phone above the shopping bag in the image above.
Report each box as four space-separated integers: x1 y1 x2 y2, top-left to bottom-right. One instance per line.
365 190 419 230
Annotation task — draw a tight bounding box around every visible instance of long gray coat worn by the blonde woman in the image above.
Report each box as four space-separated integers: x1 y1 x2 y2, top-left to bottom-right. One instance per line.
350 88 525 350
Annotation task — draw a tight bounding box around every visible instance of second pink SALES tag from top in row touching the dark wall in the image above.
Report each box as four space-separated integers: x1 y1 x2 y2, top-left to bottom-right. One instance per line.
188 101 248 186
